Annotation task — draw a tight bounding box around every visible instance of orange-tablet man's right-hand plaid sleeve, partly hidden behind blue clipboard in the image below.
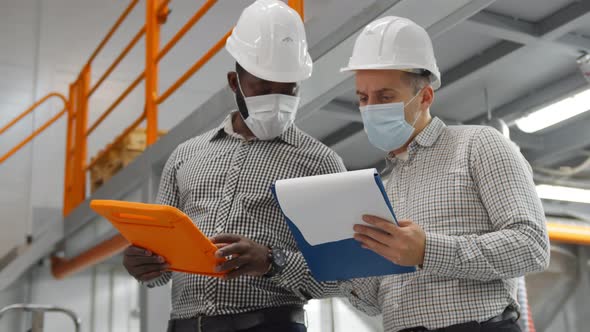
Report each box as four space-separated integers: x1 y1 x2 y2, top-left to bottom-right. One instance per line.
272 152 346 300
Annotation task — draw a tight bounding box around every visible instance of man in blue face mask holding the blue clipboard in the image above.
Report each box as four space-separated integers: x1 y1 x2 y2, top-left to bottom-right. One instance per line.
342 17 549 332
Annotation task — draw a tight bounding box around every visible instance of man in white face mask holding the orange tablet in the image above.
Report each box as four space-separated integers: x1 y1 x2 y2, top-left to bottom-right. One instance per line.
124 0 345 332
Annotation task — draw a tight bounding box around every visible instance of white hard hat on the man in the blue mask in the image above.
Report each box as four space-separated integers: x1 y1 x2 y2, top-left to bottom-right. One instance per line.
341 16 441 89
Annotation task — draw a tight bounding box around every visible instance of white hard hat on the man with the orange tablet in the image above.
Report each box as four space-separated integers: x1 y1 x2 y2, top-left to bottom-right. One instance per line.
225 0 313 83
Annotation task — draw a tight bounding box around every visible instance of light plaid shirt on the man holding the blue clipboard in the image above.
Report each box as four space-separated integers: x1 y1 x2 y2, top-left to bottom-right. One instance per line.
342 118 549 331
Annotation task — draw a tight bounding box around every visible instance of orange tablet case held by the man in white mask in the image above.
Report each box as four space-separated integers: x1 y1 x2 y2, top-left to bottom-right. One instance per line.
90 200 225 276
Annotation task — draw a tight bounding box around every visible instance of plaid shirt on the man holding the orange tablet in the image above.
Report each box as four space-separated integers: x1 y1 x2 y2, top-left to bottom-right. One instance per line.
149 112 345 319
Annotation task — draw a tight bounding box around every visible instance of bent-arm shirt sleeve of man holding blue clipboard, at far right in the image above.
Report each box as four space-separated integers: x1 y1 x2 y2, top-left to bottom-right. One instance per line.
423 128 549 281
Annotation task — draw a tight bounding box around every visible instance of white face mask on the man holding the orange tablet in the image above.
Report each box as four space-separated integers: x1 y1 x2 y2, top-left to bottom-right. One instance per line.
238 77 301 140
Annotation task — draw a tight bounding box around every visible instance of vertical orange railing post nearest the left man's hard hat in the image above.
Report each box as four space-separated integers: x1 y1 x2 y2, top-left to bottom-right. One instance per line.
145 0 161 145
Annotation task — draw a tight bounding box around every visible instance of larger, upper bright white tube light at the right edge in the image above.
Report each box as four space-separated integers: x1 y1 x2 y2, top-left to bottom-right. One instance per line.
516 89 590 133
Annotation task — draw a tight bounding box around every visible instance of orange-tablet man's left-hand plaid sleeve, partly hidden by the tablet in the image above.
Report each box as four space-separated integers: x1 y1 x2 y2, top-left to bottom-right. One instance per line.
142 148 180 288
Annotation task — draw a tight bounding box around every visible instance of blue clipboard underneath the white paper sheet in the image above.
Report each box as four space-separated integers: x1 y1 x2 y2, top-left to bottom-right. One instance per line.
271 174 416 281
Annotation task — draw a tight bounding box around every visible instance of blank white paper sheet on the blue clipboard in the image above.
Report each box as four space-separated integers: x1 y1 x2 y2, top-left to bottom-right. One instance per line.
275 168 394 245
